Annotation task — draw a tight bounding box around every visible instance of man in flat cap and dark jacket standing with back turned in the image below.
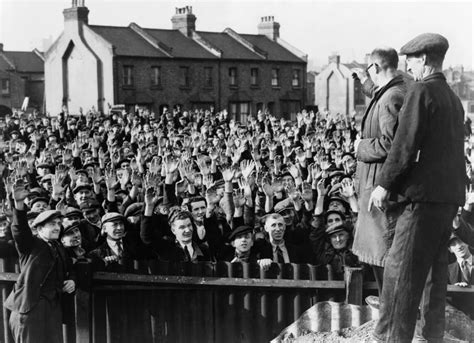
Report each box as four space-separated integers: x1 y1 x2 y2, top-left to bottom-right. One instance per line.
369 33 466 342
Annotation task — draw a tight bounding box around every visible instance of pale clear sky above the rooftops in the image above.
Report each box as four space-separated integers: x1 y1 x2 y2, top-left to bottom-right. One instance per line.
0 0 474 70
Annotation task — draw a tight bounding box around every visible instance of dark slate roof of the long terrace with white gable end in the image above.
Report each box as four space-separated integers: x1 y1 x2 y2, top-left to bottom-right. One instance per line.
89 25 304 62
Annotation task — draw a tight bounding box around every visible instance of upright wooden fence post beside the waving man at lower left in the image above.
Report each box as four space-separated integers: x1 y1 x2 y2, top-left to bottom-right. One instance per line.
74 263 92 343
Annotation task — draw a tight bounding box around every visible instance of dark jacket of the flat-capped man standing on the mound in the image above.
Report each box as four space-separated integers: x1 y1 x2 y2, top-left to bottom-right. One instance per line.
376 73 466 205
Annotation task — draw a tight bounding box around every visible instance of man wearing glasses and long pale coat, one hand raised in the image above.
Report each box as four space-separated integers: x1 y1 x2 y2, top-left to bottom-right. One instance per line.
352 48 407 306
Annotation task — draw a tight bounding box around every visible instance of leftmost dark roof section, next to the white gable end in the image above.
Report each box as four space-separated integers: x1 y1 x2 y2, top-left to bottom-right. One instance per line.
89 25 166 57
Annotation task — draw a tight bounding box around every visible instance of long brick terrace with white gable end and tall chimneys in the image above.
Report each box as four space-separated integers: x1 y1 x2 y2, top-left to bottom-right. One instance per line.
45 0 307 120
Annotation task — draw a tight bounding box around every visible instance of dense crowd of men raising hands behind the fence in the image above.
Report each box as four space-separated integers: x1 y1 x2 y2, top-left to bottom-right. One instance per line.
0 108 474 279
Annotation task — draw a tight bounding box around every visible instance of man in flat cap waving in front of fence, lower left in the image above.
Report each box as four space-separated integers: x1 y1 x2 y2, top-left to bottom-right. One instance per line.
4 180 75 343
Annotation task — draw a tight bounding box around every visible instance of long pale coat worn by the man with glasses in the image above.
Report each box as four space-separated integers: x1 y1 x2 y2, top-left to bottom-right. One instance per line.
352 75 407 266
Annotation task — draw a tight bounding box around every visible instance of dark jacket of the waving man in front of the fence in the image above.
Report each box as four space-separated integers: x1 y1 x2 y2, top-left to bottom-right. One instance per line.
4 209 75 313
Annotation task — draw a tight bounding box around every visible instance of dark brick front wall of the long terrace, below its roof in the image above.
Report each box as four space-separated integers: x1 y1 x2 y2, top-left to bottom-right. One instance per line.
114 57 306 119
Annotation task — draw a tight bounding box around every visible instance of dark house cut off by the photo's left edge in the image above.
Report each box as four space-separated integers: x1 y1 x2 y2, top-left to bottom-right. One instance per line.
0 43 44 115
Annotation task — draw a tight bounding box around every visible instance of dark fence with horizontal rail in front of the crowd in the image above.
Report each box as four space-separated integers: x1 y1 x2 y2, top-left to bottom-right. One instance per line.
0 259 472 343
